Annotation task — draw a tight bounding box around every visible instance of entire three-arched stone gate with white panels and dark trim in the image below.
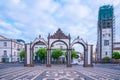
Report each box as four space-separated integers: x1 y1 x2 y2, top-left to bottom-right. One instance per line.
24 29 93 67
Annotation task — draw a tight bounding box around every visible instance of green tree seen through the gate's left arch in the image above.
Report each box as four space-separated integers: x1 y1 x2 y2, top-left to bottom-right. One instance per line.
36 48 47 63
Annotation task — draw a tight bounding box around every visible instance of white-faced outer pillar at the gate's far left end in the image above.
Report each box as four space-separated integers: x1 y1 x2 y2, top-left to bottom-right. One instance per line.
24 44 33 67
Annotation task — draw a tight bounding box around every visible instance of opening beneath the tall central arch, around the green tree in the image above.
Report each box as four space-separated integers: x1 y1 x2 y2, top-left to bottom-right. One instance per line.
50 40 68 64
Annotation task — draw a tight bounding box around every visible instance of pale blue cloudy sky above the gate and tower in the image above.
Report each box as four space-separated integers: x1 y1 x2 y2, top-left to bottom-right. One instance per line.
0 0 120 50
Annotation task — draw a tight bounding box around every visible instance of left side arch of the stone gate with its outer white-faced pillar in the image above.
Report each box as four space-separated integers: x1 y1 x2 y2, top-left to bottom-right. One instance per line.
24 36 48 67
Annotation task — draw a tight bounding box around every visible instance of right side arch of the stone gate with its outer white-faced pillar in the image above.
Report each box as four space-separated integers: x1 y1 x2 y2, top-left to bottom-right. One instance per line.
70 36 93 67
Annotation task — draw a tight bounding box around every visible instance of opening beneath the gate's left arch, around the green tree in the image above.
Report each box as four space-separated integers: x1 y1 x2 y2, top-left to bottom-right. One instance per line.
31 40 47 64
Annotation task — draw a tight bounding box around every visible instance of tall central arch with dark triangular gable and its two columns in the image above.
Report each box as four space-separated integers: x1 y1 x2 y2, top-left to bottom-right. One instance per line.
46 29 72 67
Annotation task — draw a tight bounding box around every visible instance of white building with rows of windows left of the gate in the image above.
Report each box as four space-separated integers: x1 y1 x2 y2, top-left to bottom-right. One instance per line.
0 36 24 62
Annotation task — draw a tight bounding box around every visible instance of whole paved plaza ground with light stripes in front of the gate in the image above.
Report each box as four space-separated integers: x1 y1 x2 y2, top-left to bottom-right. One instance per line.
0 63 120 80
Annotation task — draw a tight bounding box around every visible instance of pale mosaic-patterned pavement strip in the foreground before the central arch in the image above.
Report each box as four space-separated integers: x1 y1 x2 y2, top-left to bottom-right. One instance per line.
35 70 90 80
